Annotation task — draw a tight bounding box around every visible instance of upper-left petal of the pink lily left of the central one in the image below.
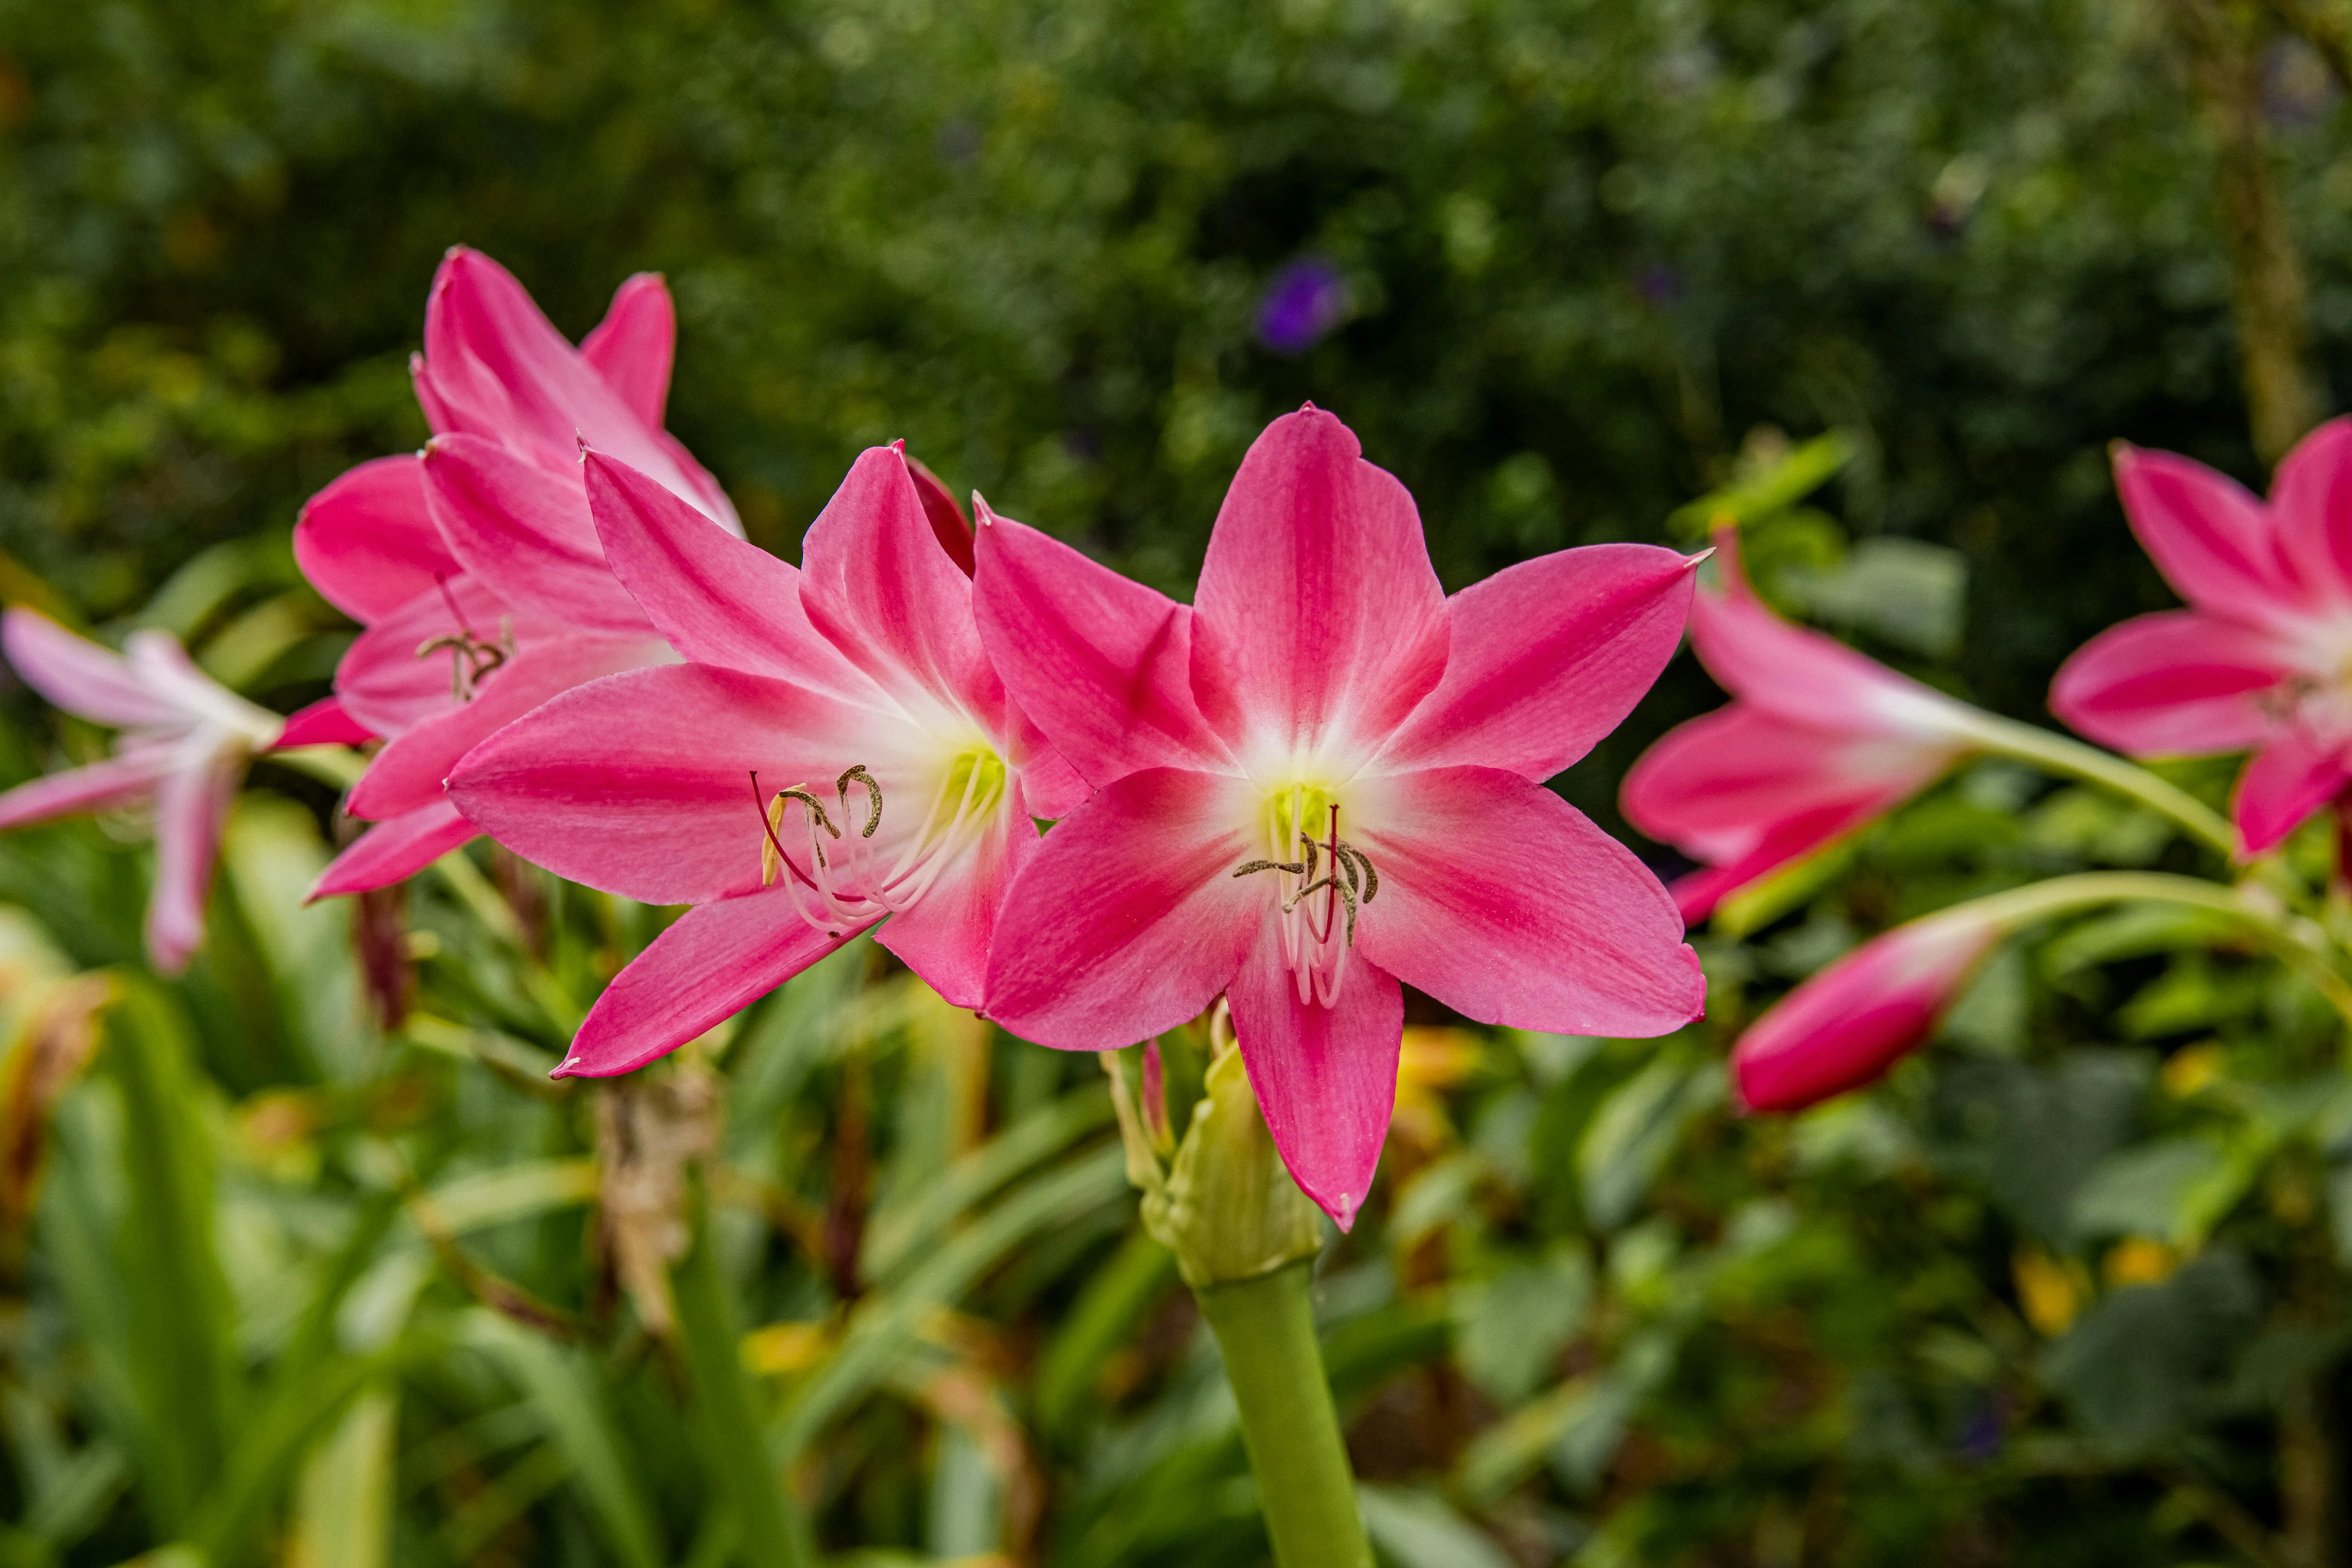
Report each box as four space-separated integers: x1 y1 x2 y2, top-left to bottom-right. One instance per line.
583 451 877 701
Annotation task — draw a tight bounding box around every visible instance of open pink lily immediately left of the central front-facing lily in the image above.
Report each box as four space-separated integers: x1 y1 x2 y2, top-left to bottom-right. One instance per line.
449 447 1082 1076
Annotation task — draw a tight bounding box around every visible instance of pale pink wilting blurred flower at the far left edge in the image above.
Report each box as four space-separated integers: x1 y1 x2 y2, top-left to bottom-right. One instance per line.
0 606 285 973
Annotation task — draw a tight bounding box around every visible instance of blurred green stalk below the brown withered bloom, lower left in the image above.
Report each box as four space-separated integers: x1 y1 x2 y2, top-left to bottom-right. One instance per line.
670 1171 816 1568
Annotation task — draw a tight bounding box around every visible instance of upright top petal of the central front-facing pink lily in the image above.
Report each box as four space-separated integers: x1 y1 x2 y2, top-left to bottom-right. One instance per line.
1194 404 1449 766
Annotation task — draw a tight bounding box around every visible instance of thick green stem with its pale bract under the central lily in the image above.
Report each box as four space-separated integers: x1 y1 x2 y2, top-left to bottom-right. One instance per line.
1103 1004 1371 1568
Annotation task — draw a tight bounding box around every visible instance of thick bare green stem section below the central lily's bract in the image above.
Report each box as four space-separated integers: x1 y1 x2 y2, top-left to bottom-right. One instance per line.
1195 1262 1371 1568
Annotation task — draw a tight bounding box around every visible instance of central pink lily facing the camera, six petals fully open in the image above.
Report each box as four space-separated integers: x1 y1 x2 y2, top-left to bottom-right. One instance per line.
974 404 1705 1227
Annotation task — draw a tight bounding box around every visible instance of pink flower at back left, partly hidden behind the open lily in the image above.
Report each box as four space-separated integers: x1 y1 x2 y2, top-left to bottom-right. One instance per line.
294 249 741 896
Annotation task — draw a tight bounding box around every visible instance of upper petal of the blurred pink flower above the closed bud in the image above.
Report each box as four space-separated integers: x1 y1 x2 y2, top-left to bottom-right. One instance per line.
1691 529 1969 741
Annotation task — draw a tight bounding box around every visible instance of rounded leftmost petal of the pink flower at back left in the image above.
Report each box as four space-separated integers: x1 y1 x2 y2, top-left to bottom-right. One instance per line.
294 454 459 625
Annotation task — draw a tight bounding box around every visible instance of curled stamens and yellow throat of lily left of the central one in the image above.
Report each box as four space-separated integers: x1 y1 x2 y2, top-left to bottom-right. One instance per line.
750 745 1007 938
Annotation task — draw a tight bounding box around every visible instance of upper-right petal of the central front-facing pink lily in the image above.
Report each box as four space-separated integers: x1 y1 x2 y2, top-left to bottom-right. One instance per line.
1381 545 1694 781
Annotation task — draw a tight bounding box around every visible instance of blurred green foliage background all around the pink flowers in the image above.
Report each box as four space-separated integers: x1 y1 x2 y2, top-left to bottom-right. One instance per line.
0 0 2352 1568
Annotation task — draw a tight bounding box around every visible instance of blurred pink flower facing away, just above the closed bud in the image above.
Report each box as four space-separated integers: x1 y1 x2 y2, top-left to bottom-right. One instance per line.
1620 529 1978 919
